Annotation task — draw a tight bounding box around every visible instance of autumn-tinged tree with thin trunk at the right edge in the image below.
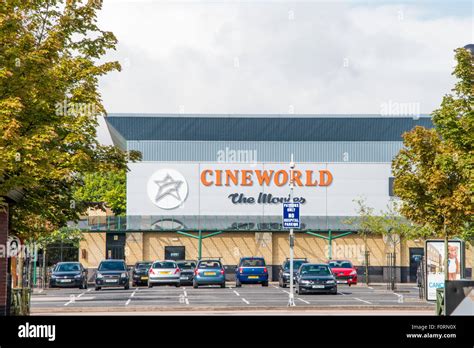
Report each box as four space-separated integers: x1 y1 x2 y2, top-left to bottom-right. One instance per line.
392 49 474 279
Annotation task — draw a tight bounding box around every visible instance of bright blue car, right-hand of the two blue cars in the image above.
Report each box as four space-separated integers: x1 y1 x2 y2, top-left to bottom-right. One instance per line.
235 257 268 287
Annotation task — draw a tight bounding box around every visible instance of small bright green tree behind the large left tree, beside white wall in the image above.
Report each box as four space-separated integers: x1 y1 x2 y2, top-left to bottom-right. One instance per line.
74 170 127 215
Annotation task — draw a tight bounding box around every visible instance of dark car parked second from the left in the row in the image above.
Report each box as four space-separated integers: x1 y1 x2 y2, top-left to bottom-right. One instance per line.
95 259 130 291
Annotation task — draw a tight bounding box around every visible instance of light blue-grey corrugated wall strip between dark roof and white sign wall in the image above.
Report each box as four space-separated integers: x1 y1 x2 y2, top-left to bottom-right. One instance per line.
127 141 403 162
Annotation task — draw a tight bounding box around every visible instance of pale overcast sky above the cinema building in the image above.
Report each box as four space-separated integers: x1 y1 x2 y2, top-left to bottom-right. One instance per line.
94 0 474 144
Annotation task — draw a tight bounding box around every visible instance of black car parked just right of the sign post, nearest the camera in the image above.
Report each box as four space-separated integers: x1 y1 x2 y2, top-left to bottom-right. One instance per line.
296 263 337 295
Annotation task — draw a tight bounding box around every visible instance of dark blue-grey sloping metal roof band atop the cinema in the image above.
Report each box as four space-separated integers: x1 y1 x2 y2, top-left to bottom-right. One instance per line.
106 114 432 141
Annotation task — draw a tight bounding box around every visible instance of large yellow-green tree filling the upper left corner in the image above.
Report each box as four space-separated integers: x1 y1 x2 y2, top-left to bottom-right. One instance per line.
0 0 138 239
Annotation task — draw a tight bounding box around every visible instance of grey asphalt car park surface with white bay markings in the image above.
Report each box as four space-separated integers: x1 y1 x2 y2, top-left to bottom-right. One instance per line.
32 283 434 314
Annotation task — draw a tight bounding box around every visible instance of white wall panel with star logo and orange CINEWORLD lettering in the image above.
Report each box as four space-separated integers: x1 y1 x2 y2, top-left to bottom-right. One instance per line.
127 161 391 216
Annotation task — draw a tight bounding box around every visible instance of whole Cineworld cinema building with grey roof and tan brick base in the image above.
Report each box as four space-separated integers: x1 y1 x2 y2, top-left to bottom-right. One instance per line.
79 114 470 282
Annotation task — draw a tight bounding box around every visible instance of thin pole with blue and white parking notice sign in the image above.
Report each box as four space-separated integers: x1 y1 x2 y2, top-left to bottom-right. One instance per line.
283 154 300 307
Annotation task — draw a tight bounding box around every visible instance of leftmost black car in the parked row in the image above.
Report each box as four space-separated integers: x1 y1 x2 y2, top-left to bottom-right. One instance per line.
49 262 87 289
